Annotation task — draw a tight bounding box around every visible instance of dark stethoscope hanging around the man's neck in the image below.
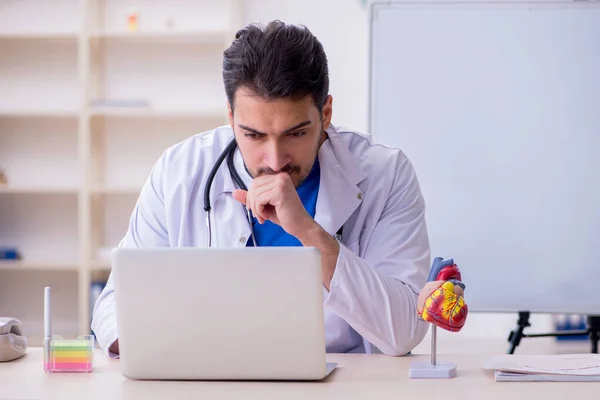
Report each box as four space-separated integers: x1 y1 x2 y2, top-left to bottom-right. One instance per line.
204 138 344 247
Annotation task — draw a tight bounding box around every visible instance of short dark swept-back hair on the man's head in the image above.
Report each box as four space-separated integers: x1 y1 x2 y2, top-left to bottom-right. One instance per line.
223 20 329 111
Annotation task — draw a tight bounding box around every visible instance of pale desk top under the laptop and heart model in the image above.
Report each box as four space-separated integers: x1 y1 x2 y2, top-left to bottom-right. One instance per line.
0 348 600 400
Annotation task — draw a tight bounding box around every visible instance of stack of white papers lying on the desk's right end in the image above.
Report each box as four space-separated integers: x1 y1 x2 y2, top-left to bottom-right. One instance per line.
484 354 600 382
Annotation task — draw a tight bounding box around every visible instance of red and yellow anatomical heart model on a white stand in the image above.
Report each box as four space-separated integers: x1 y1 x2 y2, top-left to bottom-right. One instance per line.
409 257 468 379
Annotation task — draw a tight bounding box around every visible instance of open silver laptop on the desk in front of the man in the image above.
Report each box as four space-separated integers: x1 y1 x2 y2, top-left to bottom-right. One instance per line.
112 247 336 380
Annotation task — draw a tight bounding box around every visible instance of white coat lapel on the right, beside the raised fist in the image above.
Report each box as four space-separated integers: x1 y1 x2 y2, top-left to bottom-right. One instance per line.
315 126 365 235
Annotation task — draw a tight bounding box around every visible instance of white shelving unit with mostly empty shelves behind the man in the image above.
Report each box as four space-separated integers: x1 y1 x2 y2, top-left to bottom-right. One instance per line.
0 0 242 345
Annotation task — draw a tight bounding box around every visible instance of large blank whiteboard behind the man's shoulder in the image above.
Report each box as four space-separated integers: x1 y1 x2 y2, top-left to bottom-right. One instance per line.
369 1 600 314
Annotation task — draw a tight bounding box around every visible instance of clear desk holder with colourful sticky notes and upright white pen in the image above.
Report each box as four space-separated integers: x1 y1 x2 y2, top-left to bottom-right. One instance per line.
44 287 95 372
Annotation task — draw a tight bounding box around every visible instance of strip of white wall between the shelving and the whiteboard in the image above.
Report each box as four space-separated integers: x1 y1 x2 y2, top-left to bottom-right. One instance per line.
242 0 368 132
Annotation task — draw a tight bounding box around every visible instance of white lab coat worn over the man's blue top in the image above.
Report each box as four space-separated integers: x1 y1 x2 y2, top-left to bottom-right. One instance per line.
92 126 430 355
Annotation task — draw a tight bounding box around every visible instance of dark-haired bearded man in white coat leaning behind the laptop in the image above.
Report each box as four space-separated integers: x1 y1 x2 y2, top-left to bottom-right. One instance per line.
92 21 430 356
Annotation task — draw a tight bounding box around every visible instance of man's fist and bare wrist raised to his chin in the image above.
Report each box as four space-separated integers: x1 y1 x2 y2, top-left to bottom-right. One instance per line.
233 172 340 290
